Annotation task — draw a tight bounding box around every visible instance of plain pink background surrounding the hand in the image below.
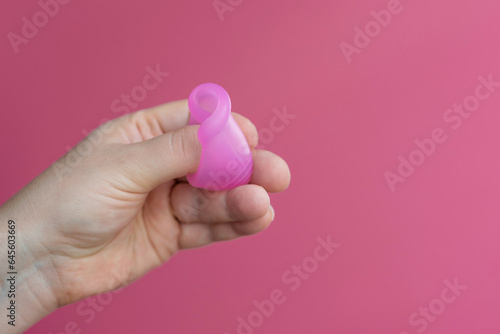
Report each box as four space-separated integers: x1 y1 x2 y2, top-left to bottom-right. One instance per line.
0 0 500 334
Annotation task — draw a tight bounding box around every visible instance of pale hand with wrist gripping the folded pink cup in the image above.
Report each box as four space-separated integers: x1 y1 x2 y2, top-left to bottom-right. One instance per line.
0 100 290 333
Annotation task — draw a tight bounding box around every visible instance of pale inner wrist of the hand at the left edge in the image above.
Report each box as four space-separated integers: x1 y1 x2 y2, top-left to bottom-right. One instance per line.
0 194 58 333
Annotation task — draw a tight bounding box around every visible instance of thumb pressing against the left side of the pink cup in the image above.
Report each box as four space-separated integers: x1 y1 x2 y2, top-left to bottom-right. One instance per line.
122 125 201 192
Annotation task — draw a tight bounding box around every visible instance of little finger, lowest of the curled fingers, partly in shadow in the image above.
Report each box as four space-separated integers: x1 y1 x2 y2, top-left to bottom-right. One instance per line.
179 207 274 249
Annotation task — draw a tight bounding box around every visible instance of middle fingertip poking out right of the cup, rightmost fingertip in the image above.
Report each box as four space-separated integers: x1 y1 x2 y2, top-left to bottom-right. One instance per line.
250 150 291 193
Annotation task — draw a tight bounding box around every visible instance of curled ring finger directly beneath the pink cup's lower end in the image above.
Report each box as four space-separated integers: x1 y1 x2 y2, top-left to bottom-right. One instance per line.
171 183 270 224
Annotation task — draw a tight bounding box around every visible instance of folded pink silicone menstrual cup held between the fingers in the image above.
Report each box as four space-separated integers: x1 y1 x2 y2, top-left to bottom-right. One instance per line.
187 83 253 190
